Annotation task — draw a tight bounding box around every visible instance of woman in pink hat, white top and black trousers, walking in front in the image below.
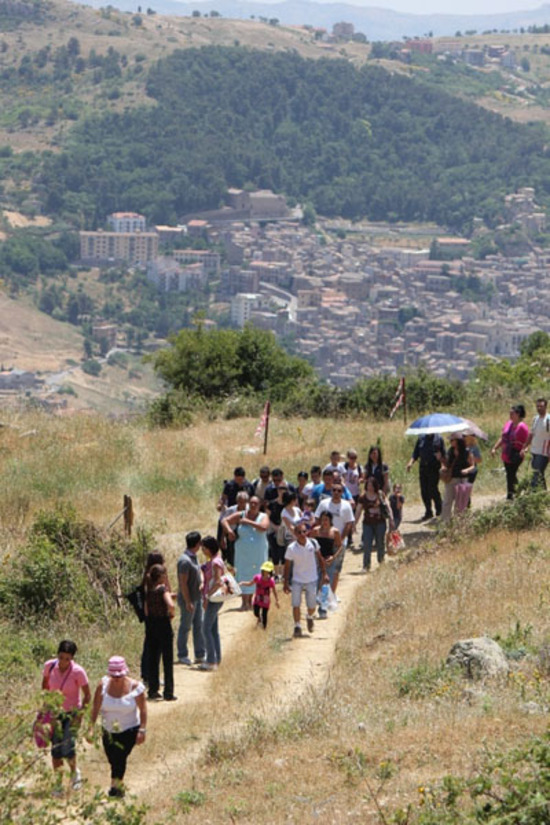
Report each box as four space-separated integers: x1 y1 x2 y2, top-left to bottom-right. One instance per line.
90 656 147 797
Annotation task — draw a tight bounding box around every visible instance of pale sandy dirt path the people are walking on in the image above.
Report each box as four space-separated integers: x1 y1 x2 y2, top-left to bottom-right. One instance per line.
84 497 500 801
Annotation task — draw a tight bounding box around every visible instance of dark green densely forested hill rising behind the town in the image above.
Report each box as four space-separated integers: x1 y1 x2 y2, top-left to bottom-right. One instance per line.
40 47 550 230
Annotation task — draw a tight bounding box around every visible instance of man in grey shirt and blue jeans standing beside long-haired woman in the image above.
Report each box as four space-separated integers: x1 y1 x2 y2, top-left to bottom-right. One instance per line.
177 530 206 665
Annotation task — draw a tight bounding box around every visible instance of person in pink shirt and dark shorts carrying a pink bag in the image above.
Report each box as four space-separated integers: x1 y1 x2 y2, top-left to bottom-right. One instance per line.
42 639 91 796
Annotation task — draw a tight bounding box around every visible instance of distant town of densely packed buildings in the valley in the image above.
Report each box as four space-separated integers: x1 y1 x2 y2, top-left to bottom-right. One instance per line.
75 188 550 386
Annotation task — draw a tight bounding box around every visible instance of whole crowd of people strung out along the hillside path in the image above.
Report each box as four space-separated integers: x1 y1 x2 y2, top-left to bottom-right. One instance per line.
38 398 550 798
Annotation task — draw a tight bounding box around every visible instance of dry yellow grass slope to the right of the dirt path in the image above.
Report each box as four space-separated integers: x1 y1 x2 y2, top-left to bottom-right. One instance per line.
140 534 549 823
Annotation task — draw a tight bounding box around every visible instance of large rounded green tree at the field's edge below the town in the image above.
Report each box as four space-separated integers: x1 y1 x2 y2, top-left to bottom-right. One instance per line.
149 324 316 400
